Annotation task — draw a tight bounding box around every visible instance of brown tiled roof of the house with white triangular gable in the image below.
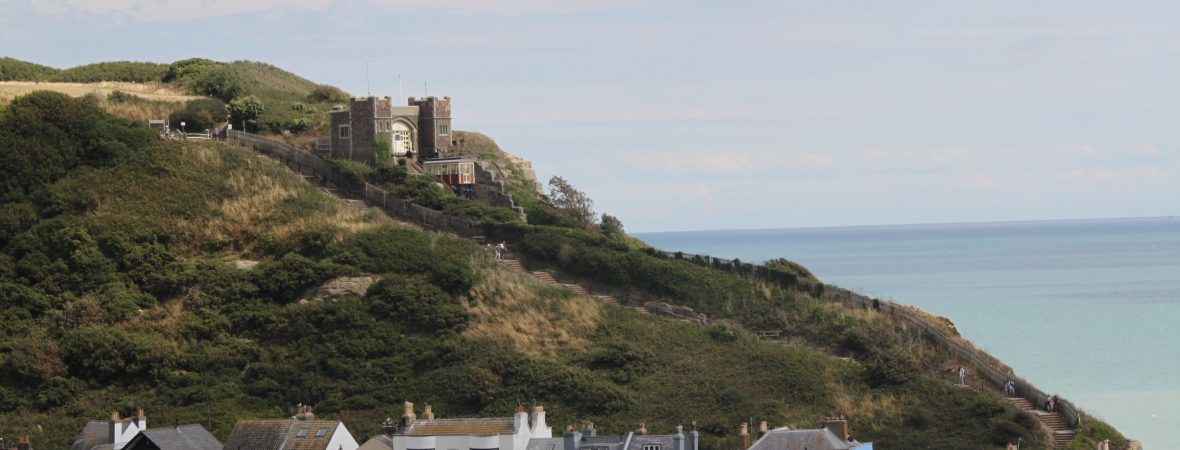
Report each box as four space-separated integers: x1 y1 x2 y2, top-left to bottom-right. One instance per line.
224 419 340 450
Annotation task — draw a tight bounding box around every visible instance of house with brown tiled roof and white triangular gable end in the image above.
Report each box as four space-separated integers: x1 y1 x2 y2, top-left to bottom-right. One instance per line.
224 406 359 450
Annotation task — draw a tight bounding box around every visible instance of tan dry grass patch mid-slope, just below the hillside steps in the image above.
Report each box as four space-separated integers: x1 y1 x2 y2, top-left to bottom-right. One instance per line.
463 257 603 357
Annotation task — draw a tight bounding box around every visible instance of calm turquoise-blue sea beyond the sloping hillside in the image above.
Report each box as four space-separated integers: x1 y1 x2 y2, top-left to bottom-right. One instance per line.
635 217 1180 450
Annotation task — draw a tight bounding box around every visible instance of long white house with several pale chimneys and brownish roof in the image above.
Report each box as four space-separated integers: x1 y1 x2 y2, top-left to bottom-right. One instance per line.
360 402 553 450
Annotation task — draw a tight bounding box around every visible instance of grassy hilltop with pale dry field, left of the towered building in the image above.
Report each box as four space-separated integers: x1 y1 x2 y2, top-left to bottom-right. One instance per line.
0 58 348 133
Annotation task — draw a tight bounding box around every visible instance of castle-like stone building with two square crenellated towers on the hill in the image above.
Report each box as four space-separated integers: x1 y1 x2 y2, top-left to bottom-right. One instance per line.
328 97 454 162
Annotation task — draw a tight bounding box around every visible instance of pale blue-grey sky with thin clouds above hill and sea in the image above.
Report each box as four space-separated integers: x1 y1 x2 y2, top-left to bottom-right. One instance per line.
0 0 1180 233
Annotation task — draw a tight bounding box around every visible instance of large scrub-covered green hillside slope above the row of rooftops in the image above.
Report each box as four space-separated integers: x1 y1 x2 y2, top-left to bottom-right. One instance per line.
0 92 1123 450
